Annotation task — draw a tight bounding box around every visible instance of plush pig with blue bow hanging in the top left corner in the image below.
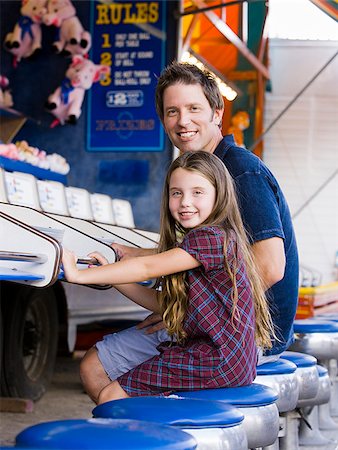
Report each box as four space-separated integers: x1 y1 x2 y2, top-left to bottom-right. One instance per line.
4 0 47 66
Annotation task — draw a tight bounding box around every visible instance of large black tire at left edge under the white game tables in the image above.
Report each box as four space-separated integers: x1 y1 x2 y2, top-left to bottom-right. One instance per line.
1 283 59 400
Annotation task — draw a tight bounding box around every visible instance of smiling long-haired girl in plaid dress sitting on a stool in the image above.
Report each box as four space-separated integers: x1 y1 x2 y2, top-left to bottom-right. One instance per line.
63 151 273 403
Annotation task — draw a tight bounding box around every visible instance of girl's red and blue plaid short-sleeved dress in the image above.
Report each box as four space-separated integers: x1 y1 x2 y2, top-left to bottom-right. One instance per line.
118 227 257 396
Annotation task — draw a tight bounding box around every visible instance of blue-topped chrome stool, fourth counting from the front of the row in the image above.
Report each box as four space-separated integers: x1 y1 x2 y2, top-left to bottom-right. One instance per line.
282 351 319 400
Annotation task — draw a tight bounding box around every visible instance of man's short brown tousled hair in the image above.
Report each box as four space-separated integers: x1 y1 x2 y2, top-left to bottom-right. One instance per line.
155 61 224 122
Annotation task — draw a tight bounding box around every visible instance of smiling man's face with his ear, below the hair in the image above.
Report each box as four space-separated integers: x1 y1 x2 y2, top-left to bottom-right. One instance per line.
163 83 223 153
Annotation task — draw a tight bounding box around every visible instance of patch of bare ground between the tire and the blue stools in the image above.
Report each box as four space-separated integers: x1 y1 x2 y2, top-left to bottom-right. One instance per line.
0 357 95 448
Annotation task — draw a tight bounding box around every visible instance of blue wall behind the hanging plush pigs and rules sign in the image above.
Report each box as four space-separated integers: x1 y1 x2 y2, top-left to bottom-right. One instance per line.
0 0 180 231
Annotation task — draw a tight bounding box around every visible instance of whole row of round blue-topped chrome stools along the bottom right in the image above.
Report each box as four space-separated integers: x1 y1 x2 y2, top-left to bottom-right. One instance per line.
3 317 338 450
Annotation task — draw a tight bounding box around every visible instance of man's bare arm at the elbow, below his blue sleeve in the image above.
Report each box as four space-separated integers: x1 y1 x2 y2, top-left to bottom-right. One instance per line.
252 237 286 289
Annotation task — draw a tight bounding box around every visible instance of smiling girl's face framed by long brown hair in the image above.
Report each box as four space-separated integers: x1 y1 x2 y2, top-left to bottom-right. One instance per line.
169 167 216 228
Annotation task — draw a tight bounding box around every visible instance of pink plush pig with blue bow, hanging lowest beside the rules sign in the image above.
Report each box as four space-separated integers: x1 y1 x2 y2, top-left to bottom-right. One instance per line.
46 55 110 127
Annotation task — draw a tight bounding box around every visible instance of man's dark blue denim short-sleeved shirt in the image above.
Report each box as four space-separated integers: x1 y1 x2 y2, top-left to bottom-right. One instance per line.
214 135 299 355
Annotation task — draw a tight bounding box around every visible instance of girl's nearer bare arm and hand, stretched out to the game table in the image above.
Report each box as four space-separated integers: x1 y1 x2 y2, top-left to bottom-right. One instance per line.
62 248 200 285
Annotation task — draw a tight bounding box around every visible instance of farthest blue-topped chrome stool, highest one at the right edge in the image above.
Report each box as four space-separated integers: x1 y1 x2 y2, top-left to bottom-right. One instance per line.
290 319 338 416
